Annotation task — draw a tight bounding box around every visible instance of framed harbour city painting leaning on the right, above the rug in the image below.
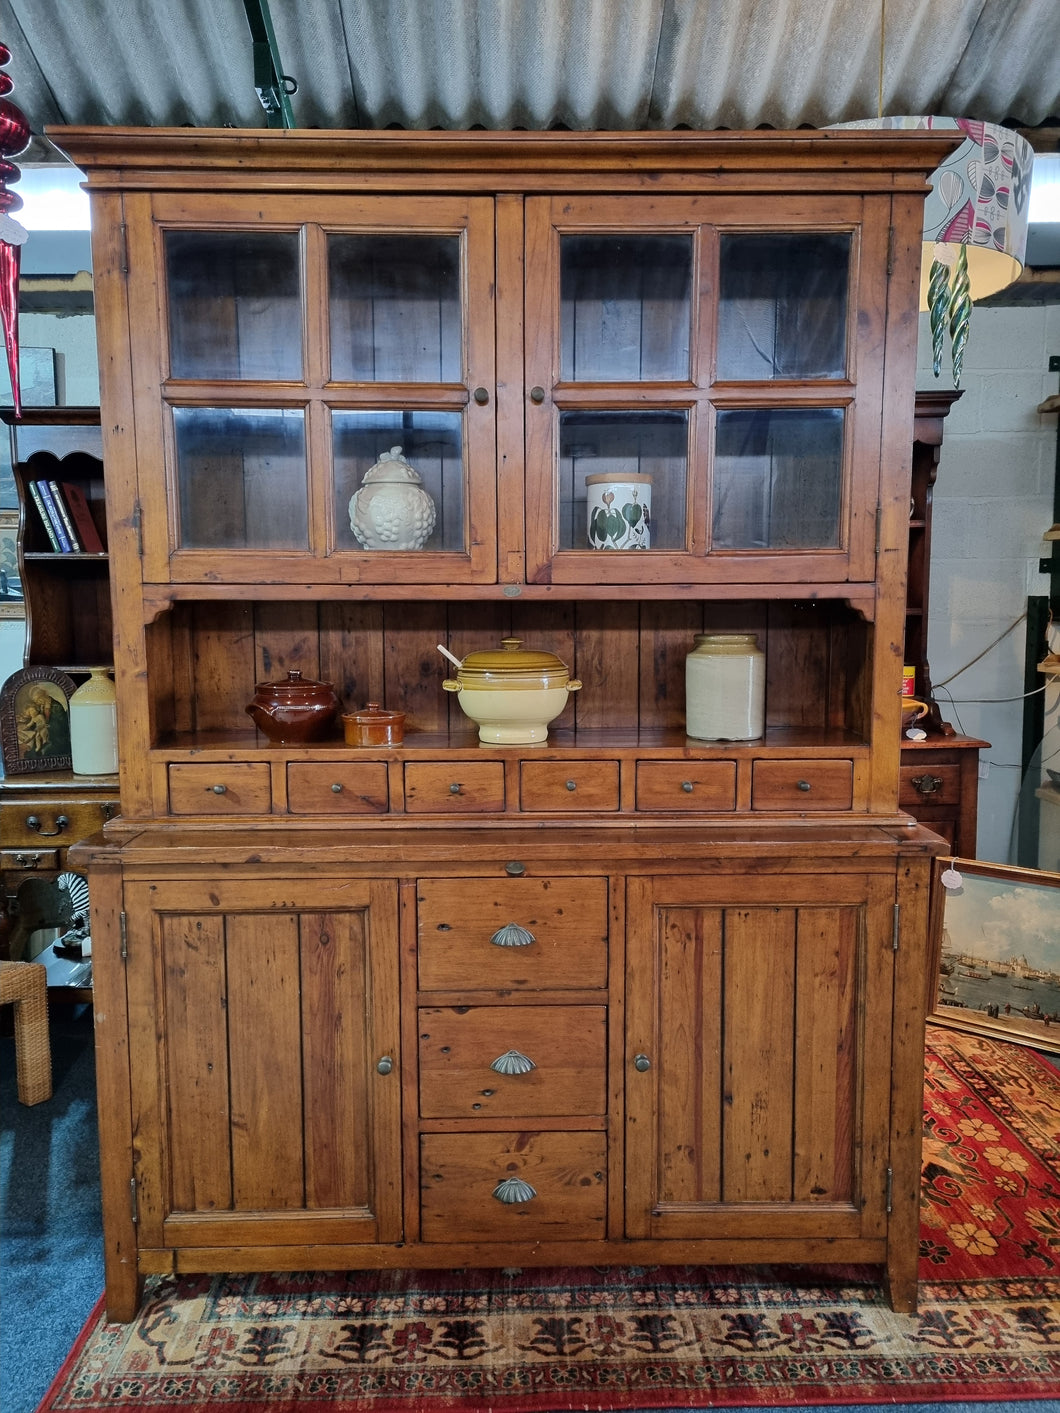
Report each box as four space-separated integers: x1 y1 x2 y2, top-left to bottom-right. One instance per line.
927 858 1060 1053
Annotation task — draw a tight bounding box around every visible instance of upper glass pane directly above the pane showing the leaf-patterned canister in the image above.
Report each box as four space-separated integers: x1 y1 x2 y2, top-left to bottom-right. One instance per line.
560 236 693 383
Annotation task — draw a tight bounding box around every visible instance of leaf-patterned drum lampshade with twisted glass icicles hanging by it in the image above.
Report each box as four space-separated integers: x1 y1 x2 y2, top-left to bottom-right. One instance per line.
830 117 1035 384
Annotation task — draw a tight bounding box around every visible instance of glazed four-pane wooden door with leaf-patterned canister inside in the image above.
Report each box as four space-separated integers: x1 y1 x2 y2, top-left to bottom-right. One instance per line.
526 196 890 585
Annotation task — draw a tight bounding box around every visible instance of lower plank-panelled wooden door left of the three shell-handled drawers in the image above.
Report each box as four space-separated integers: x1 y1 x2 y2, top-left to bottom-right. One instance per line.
126 877 400 1249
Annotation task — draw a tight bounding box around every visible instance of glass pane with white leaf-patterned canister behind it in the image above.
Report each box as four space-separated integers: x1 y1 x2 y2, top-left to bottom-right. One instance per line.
558 411 688 550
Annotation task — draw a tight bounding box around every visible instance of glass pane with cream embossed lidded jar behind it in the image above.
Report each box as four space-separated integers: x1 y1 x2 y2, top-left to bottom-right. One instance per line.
331 411 465 552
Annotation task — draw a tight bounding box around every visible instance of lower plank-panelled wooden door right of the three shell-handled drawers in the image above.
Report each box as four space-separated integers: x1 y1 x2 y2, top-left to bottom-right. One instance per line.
625 875 895 1239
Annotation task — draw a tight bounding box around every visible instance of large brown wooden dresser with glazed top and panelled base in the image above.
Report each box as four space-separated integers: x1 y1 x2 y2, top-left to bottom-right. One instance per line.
51 129 953 1320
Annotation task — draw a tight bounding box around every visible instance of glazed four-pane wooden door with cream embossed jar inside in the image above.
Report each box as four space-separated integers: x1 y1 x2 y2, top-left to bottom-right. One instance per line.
127 195 496 584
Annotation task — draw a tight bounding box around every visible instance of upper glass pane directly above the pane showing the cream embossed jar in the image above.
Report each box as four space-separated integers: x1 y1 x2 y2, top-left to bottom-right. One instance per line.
328 235 464 383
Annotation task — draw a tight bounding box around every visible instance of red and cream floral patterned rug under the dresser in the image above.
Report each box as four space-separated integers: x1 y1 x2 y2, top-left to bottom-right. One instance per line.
33 1027 1060 1413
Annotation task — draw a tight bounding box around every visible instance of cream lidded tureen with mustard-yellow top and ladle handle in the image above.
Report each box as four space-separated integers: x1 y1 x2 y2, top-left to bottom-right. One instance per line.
442 637 581 746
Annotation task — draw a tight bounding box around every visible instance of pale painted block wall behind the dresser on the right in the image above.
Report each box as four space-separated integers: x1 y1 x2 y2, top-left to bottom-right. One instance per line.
917 305 1060 868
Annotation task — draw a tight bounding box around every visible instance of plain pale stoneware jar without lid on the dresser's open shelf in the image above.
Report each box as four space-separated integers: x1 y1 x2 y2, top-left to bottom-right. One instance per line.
684 633 766 740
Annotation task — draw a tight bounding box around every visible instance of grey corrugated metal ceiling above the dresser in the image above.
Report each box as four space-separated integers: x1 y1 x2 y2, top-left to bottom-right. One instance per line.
0 0 1060 147
